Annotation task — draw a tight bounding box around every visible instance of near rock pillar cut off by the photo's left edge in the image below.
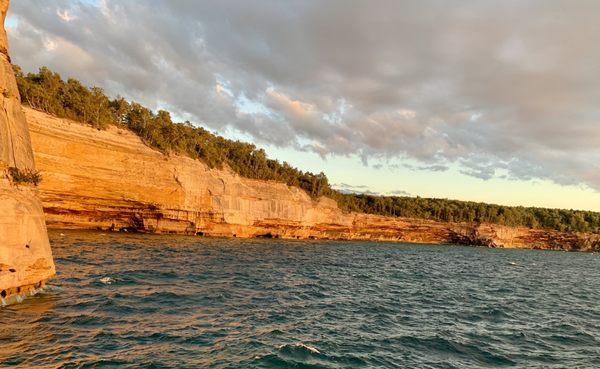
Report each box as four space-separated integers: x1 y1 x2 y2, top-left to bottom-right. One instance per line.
0 0 54 304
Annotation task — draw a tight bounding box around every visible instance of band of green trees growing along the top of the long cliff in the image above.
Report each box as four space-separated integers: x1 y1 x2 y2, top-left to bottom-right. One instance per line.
14 66 600 233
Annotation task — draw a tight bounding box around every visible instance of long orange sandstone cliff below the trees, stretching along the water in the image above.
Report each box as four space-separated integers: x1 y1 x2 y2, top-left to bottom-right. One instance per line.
25 109 600 250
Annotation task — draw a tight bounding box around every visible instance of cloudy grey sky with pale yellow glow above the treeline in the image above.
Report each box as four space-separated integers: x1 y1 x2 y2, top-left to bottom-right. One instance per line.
7 0 600 211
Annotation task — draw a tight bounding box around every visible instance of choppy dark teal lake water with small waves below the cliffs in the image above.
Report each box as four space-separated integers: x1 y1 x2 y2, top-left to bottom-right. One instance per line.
0 232 600 368
